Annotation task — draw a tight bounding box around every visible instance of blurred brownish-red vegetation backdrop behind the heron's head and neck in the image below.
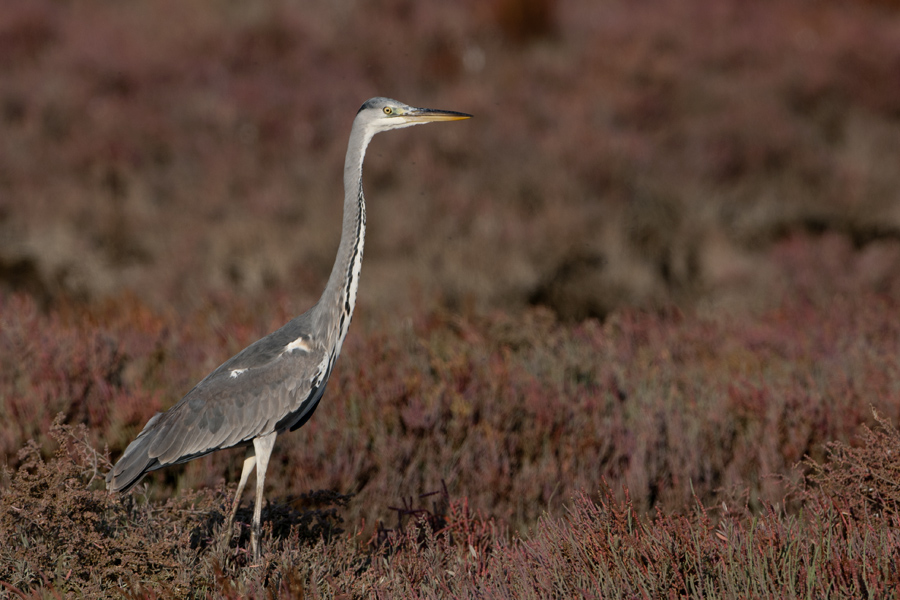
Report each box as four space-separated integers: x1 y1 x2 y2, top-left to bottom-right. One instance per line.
0 0 900 321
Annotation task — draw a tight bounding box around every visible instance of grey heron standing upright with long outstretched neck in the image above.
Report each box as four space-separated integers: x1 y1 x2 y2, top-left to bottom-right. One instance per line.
106 98 471 560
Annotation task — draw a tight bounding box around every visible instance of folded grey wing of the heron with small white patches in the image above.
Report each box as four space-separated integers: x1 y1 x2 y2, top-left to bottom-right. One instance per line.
107 319 333 491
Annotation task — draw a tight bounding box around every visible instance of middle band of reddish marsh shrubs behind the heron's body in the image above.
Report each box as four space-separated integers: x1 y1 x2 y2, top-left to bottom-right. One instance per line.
0 245 900 532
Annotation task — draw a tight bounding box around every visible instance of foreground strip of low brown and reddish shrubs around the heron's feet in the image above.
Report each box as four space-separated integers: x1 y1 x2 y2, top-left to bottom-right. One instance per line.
0 418 900 598
